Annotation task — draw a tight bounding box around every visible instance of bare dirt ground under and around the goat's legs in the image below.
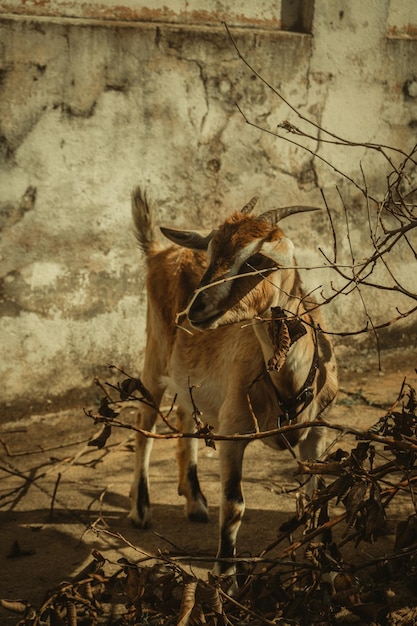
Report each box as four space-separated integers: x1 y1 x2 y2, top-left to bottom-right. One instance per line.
0 349 417 625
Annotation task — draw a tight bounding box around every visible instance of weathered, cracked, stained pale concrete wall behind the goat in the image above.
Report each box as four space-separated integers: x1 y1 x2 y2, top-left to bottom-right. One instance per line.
0 0 417 414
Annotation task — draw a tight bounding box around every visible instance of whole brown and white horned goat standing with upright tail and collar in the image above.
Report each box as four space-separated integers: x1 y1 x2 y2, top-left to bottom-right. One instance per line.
130 189 337 574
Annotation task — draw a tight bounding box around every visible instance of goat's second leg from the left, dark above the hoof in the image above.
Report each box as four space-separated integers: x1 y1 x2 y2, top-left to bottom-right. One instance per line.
177 409 208 522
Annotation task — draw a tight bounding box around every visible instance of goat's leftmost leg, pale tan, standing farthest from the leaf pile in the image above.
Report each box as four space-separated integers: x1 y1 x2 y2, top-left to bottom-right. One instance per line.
128 390 162 528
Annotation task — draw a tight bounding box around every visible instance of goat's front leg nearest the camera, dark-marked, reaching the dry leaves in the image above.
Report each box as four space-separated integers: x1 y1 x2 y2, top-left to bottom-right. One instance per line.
214 441 247 593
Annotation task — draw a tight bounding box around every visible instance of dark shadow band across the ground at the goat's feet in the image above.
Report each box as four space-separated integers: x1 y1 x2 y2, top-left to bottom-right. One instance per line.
0 493 288 604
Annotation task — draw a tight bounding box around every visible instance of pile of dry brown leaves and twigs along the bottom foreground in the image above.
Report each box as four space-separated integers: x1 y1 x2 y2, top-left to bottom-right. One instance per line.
1 372 417 626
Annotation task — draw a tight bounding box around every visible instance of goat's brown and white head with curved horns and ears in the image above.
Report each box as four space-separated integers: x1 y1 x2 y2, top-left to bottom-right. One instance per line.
161 198 316 330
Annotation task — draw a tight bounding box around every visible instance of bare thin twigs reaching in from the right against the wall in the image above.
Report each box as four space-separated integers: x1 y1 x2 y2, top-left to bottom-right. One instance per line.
225 24 417 355
